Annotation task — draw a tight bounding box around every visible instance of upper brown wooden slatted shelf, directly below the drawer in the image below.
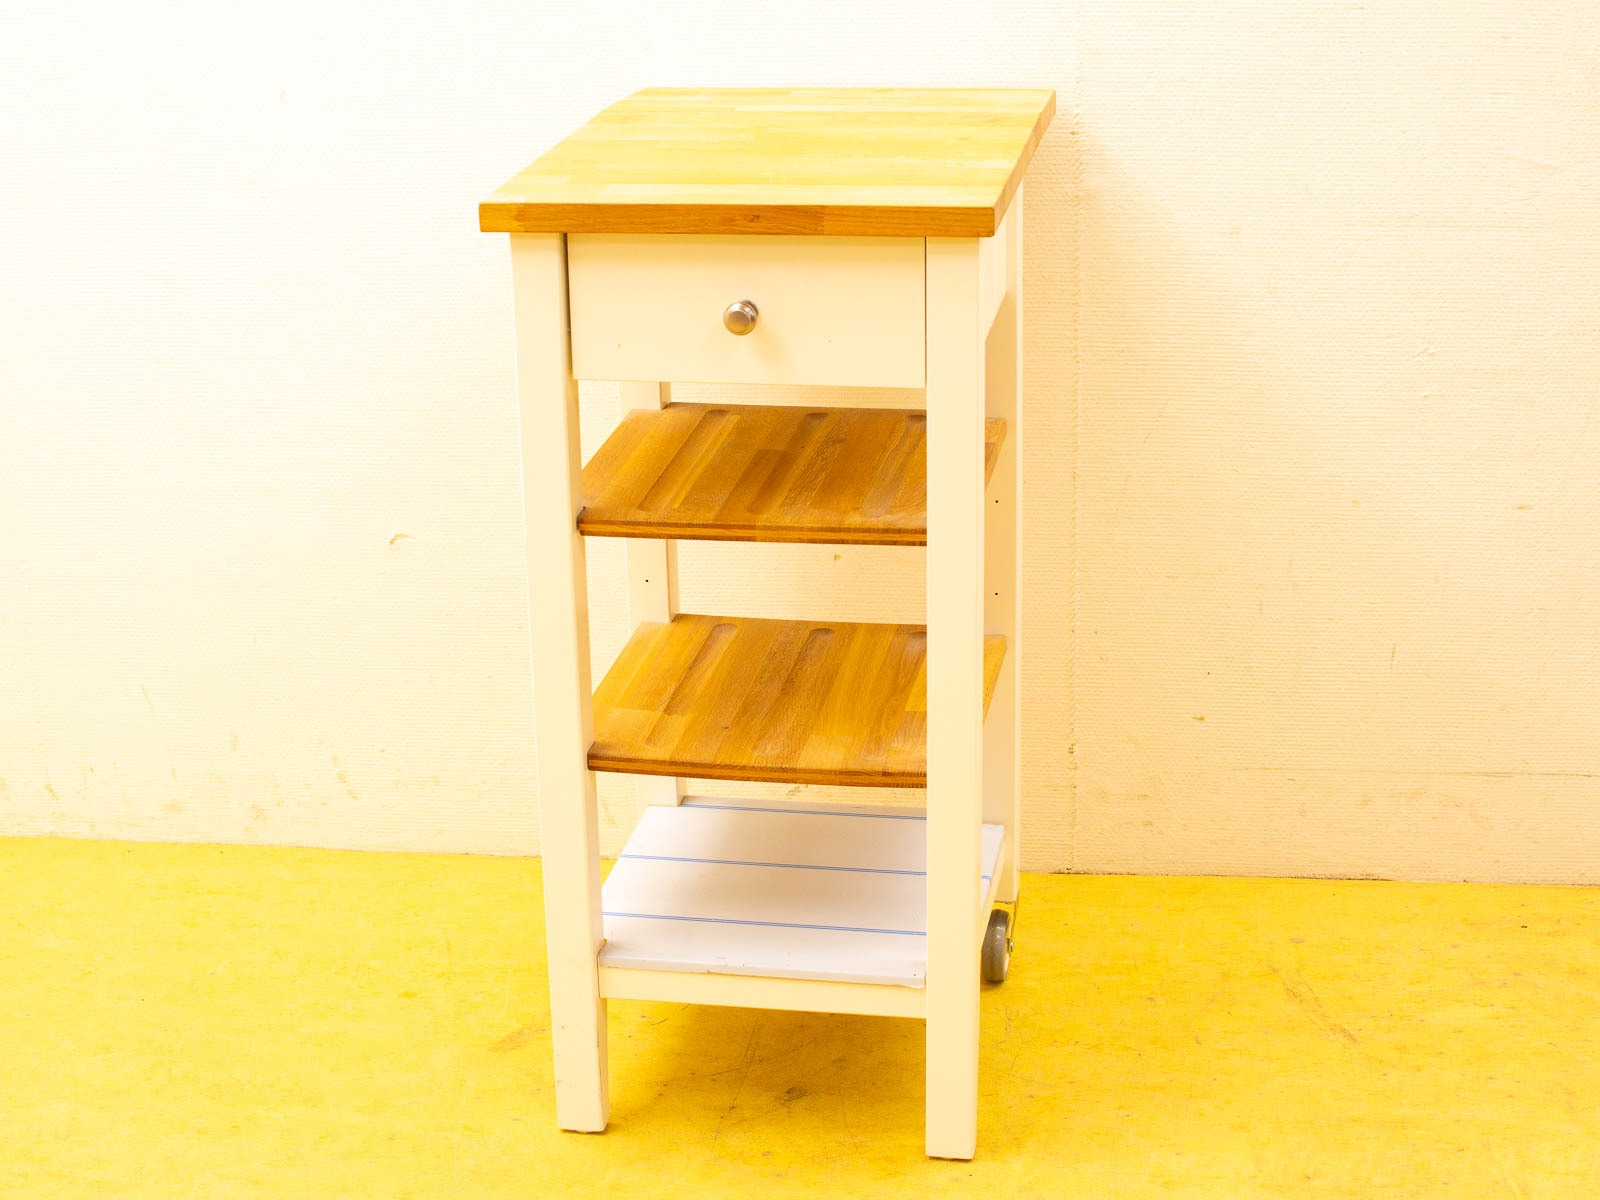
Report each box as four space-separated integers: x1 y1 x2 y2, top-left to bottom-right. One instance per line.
578 405 1005 546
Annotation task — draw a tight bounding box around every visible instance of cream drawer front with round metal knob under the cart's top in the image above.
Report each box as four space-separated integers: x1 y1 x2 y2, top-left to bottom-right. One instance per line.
566 234 926 387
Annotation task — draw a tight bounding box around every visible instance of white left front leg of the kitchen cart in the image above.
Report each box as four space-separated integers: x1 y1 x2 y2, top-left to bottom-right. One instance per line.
510 234 611 1131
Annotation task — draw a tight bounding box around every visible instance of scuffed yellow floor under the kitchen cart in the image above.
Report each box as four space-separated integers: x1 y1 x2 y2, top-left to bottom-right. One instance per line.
0 840 1600 1200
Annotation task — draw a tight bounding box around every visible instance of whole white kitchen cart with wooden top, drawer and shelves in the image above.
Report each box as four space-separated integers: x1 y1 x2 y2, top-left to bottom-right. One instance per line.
480 88 1054 1158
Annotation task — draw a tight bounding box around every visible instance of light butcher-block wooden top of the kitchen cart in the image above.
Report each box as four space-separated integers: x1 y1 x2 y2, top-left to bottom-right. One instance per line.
478 88 1056 237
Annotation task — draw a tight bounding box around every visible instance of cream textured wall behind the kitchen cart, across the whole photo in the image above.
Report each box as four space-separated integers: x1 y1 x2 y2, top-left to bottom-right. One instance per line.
0 0 1600 882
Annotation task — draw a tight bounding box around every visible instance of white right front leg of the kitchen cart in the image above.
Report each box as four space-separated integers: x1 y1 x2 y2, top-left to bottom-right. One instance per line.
926 238 984 1158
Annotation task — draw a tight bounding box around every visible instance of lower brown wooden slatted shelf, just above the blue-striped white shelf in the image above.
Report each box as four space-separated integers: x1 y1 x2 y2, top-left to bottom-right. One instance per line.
589 614 1005 787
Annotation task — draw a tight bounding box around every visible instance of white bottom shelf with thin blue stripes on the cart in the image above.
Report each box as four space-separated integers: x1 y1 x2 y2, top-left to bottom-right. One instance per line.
600 798 1005 987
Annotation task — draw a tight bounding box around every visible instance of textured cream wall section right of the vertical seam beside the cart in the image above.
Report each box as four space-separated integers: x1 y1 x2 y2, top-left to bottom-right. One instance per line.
1072 0 1600 882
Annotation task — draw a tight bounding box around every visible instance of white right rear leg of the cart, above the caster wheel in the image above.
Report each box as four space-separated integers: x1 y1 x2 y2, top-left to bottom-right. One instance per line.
984 187 1022 904
